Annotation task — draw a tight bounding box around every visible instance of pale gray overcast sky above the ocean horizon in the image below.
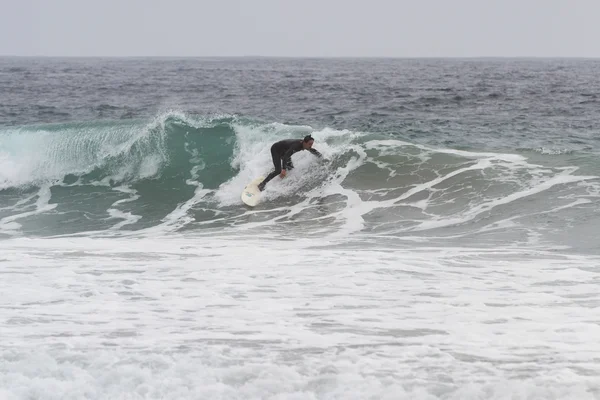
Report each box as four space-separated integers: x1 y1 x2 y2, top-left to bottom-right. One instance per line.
0 0 600 57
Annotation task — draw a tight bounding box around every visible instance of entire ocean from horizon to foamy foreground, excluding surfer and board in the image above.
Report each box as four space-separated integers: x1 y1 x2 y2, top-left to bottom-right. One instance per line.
0 58 600 400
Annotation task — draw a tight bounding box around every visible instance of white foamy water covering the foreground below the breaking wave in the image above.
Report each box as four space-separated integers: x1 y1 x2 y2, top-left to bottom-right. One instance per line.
0 237 600 400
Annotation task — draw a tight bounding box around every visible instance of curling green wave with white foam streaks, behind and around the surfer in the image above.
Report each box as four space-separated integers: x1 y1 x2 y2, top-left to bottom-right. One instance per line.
0 111 600 250
